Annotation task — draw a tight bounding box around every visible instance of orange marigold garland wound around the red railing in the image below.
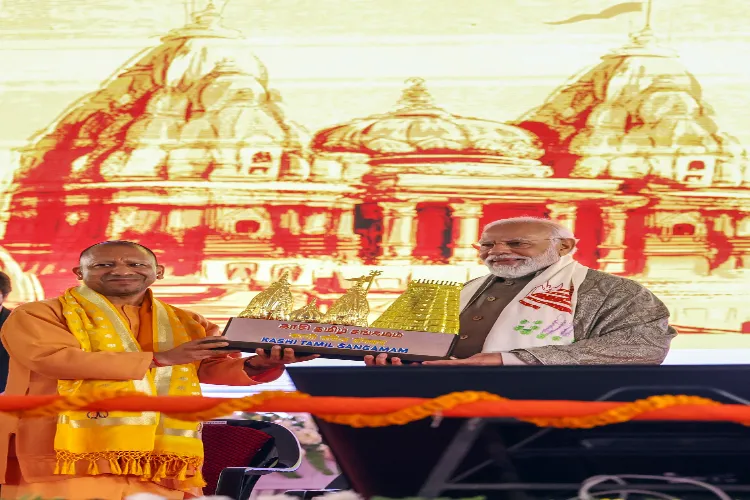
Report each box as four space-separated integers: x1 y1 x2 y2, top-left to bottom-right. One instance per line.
5 391 750 429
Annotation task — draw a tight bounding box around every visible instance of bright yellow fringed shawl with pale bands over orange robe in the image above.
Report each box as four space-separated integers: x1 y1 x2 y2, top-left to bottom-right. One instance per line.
55 286 206 491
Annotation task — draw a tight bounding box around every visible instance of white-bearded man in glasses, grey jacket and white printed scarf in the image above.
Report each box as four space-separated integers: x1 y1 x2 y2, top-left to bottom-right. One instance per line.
365 217 676 366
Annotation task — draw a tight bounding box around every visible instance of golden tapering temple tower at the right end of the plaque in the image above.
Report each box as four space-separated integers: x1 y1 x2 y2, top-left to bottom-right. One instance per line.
372 280 463 334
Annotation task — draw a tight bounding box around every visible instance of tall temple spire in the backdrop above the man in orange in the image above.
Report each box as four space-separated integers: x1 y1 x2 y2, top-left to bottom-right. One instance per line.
18 3 309 183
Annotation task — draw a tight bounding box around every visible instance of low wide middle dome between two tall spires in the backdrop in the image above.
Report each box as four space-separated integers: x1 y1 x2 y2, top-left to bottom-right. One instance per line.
312 78 544 160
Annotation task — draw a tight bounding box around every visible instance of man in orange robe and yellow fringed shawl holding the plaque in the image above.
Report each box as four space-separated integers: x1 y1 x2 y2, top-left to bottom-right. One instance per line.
0 241 310 500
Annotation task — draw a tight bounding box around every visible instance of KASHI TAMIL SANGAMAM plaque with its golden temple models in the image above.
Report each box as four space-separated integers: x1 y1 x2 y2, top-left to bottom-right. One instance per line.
224 271 462 361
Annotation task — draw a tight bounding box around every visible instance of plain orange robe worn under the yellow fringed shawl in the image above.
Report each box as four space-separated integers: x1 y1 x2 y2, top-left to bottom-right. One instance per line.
0 299 283 498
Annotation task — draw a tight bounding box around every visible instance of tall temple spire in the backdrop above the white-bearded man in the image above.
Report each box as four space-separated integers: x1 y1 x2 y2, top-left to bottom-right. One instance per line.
519 28 747 185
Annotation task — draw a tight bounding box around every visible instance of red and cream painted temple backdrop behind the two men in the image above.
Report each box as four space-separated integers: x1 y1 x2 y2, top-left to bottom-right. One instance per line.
0 0 750 356
